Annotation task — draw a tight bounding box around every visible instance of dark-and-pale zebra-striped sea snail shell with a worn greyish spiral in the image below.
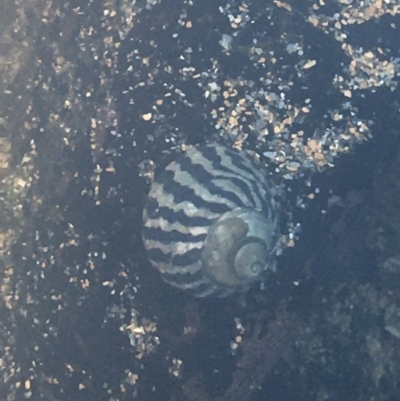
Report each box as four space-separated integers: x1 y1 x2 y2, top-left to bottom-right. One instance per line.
143 145 279 297
